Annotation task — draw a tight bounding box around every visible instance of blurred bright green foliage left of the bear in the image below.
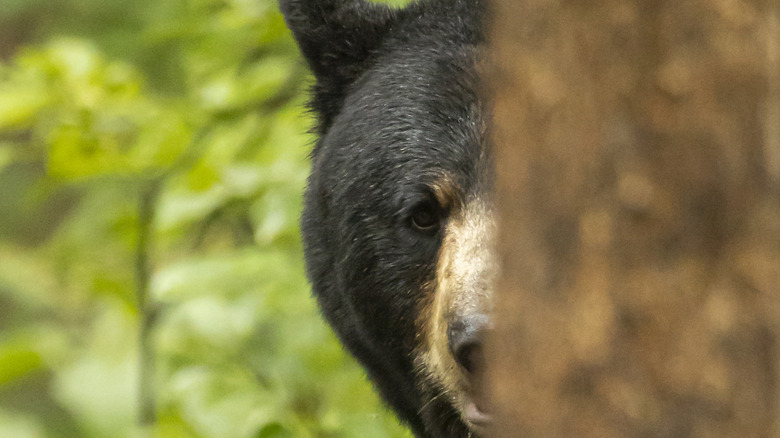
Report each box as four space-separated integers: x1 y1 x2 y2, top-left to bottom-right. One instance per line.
0 0 409 438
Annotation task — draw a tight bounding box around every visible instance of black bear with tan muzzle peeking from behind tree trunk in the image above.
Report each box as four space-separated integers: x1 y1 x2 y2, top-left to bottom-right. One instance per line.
280 0 495 437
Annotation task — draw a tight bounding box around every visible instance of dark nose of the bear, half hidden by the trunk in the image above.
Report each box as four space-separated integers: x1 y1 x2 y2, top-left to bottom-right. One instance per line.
447 314 490 374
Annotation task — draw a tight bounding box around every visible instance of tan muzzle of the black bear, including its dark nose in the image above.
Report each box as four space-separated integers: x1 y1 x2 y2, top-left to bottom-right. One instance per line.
419 199 496 435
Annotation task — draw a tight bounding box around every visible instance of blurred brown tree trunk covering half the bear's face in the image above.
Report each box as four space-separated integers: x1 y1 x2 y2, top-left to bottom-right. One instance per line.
488 0 780 438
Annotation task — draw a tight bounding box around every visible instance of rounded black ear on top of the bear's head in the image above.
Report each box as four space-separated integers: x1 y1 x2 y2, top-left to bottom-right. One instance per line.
279 0 396 132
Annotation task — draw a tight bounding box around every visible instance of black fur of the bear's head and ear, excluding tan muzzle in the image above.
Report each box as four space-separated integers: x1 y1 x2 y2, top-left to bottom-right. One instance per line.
280 0 487 437
